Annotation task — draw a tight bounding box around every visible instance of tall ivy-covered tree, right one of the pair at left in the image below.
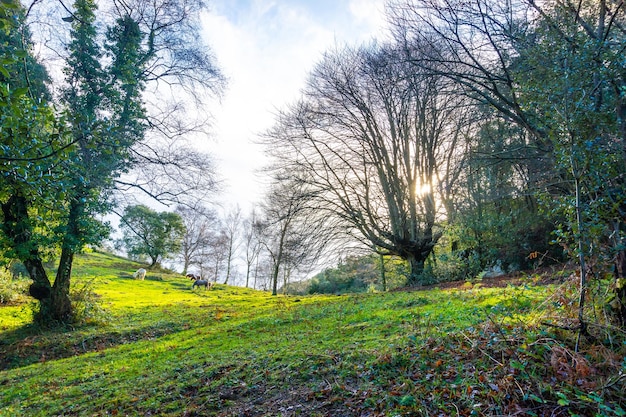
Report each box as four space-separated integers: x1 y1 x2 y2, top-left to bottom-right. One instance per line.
45 0 146 319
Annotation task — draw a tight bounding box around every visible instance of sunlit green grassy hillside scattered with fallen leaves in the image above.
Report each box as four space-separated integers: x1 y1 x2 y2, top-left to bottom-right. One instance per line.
0 254 626 416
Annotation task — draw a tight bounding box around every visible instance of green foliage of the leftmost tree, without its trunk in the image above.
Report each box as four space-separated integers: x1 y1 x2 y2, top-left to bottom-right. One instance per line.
0 2 67 210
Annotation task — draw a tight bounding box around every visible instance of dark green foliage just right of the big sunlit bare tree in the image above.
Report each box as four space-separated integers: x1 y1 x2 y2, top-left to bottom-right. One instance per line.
446 110 562 274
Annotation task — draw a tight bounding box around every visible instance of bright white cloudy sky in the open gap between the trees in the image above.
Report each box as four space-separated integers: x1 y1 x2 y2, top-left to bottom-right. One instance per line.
201 0 386 212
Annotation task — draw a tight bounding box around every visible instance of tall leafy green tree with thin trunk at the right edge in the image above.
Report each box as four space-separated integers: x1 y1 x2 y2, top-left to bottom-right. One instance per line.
520 2 626 326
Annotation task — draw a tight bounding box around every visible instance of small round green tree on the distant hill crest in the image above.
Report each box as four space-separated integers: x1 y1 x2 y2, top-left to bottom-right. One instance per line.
121 205 185 267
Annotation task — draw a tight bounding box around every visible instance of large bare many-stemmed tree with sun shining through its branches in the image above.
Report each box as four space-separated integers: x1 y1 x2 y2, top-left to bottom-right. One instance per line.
268 45 464 285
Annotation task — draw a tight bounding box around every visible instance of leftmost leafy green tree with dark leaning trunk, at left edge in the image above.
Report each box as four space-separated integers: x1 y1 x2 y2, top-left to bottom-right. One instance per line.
0 2 73 317
